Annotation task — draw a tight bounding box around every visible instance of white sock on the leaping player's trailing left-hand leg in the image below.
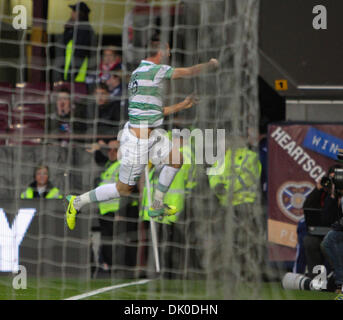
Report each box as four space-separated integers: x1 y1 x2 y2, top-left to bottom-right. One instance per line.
74 183 120 210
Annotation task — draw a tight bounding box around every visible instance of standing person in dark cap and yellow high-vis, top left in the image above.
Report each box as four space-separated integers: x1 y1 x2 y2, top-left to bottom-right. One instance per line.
58 2 94 82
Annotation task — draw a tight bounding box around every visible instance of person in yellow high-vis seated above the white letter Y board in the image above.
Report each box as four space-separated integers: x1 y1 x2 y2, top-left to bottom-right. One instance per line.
20 165 63 199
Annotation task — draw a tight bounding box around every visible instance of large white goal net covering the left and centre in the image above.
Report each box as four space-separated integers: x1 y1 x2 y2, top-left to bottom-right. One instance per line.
0 0 266 299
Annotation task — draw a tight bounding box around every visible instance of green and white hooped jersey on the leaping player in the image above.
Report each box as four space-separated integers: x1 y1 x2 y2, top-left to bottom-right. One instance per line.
128 60 174 127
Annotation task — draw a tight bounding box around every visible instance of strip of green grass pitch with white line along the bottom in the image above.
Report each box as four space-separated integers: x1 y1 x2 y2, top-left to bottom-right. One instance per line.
0 277 336 300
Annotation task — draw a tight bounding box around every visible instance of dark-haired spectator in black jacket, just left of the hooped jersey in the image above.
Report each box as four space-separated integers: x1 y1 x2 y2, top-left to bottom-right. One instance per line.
89 83 121 136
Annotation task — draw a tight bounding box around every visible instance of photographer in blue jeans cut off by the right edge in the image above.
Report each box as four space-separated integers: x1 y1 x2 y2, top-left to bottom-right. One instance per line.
321 149 343 293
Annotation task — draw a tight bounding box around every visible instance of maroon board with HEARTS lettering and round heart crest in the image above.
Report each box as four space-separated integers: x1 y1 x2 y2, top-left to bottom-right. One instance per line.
268 124 343 261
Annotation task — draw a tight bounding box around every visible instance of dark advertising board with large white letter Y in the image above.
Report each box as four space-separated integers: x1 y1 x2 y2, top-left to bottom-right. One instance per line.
0 199 90 277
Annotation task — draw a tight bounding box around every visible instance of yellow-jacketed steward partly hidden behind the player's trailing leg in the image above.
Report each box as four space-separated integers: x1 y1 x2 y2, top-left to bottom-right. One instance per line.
87 140 138 275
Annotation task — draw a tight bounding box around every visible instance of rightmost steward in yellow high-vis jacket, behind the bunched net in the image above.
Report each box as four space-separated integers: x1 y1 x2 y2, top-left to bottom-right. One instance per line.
208 146 264 279
